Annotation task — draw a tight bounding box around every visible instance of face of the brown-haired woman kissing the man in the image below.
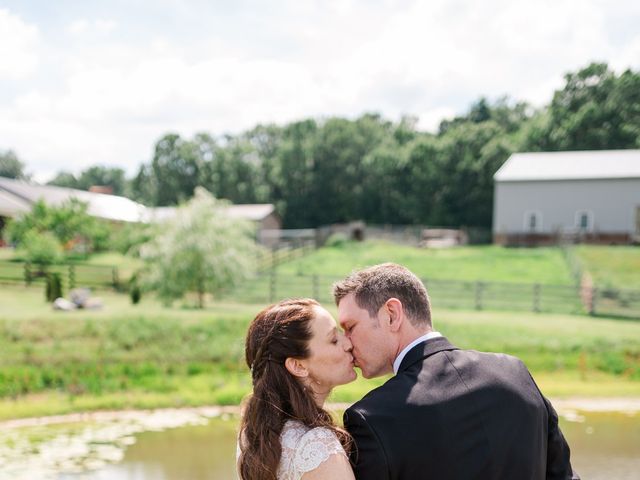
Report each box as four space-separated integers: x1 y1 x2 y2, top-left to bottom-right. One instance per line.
304 307 357 391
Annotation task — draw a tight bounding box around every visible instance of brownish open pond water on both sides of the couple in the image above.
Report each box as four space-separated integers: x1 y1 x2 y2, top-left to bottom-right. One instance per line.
59 413 640 480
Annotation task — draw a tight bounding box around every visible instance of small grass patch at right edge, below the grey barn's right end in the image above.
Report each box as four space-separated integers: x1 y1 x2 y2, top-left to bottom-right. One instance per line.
574 245 640 290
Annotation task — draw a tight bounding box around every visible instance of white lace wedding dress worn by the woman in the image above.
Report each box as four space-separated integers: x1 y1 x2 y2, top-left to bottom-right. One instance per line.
238 420 347 480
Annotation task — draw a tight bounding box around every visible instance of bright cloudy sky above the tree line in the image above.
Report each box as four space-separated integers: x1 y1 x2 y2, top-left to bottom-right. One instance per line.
0 0 640 181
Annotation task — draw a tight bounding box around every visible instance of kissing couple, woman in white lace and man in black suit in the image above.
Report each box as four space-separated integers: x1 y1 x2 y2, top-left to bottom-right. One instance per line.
237 263 579 480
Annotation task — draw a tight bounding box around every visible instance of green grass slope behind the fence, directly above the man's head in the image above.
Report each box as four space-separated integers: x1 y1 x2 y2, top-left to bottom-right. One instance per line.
279 241 573 285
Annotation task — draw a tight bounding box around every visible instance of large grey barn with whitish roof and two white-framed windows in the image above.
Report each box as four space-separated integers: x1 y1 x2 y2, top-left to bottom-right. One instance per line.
493 150 640 245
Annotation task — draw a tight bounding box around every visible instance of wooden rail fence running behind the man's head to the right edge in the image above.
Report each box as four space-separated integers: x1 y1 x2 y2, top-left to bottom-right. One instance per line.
223 268 640 318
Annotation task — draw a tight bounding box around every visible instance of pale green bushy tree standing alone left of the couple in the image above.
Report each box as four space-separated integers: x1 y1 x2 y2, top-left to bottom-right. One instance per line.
141 187 257 308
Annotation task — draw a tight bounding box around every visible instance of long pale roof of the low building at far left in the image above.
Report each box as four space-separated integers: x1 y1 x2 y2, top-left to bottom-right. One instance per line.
0 177 145 222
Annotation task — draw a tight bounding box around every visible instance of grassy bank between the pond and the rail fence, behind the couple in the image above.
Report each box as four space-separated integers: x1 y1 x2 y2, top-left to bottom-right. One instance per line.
0 286 640 419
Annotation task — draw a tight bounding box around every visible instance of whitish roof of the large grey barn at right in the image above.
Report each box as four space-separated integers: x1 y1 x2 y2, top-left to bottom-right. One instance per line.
493 150 640 182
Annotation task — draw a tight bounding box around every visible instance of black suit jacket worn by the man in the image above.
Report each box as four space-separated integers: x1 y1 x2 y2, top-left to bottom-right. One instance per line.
344 337 578 480
